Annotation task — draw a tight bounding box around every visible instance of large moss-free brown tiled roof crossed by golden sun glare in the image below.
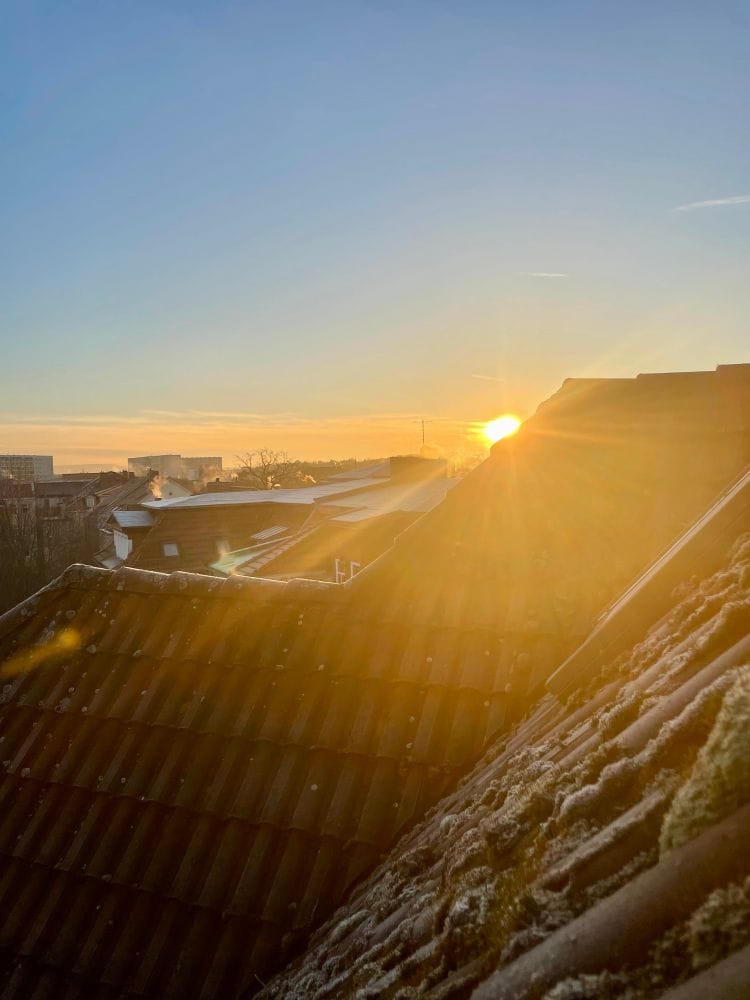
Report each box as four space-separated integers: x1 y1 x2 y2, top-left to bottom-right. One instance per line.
0 372 748 996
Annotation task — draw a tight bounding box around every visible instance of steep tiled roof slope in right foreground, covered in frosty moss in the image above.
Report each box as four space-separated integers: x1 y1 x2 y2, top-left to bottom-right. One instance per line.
264 473 750 1000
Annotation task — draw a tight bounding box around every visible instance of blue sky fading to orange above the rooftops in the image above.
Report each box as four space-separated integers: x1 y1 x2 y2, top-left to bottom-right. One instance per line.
0 0 750 466
